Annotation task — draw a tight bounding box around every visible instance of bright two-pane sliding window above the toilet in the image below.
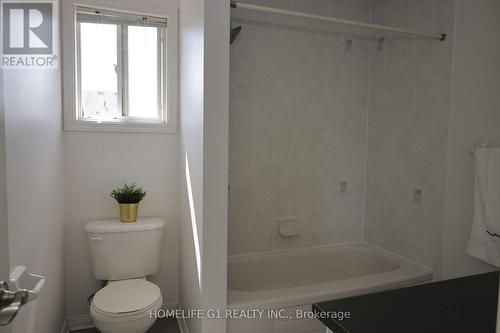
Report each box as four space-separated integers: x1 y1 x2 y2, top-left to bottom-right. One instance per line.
65 6 175 131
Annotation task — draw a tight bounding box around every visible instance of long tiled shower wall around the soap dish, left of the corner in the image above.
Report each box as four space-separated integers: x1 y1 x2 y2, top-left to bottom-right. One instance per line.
229 0 371 254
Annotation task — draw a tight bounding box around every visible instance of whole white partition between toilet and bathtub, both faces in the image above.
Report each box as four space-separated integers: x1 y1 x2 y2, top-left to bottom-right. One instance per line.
179 0 229 333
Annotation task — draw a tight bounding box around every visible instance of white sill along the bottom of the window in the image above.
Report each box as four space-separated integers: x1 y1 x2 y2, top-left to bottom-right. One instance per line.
64 120 177 133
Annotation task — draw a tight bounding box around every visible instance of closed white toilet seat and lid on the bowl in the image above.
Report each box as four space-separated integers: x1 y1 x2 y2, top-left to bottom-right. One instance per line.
91 279 162 318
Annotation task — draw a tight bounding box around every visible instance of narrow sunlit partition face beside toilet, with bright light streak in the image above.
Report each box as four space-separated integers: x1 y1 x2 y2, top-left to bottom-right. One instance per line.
179 0 204 333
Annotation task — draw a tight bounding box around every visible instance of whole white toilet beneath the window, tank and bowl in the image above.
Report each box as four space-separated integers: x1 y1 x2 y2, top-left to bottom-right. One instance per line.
85 218 165 333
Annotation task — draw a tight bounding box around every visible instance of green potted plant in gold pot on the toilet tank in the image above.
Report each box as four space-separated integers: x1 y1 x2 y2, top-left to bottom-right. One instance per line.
110 183 146 223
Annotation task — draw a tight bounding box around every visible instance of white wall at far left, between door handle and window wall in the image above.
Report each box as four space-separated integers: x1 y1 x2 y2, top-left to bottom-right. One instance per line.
4 24 66 333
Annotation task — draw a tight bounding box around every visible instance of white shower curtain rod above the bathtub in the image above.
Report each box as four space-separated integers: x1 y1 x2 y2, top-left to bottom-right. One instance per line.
231 0 446 41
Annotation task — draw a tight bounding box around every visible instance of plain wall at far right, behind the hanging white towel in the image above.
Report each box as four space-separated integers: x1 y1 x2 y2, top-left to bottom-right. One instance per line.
443 0 500 278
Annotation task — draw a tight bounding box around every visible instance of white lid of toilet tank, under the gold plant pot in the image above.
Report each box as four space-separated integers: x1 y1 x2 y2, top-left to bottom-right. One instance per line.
85 217 165 234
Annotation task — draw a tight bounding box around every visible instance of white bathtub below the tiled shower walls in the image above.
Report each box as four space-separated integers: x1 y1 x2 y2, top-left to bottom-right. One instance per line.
228 244 432 333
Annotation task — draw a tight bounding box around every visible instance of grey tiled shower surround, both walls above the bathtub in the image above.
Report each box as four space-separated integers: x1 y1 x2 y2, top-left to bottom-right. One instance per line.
229 0 454 270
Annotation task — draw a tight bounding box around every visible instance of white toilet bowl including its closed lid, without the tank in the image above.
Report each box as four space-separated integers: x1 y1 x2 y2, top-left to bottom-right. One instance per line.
90 279 162 333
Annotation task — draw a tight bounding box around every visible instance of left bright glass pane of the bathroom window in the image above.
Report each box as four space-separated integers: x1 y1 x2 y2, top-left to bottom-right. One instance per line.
80 23 121 119
